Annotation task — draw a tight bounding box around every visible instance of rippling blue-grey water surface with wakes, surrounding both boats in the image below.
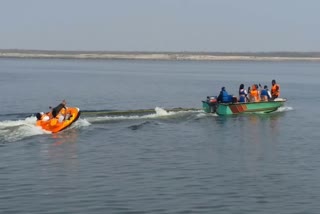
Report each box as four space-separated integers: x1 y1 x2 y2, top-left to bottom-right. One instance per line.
0 59 320 214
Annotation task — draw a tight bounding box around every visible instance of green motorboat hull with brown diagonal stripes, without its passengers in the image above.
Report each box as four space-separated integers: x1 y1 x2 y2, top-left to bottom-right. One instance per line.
202 97 287 115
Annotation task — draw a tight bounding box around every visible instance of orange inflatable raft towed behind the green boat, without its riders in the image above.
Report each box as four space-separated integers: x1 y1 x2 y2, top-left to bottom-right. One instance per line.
36 107 80 133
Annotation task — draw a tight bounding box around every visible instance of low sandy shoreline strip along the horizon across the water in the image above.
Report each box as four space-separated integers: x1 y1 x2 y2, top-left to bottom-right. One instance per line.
0 49 320 61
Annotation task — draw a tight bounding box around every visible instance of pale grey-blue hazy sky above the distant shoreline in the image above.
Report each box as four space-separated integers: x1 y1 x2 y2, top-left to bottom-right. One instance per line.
0 0 320 52
